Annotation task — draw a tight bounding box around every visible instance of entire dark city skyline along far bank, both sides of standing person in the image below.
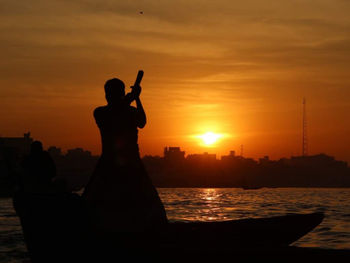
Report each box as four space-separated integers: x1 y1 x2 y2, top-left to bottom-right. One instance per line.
0 133 350 196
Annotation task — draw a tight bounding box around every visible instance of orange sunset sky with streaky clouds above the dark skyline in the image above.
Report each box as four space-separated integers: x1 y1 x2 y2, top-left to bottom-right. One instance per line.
0 0 350 161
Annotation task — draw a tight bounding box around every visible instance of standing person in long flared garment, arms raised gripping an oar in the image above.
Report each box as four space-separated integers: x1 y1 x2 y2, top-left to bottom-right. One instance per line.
83 78 167 235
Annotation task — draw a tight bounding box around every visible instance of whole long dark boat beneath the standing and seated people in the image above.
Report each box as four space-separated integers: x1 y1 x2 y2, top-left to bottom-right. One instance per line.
14 195 324 261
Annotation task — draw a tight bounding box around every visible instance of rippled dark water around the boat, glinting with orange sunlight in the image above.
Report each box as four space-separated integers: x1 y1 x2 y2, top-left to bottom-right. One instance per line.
0 188 350 262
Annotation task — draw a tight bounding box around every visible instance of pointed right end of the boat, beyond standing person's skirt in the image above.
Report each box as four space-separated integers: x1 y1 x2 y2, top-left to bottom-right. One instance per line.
164 212 324 247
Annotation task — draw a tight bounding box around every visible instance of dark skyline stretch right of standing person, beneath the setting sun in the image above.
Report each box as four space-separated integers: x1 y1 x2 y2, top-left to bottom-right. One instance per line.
144 150 350 189
